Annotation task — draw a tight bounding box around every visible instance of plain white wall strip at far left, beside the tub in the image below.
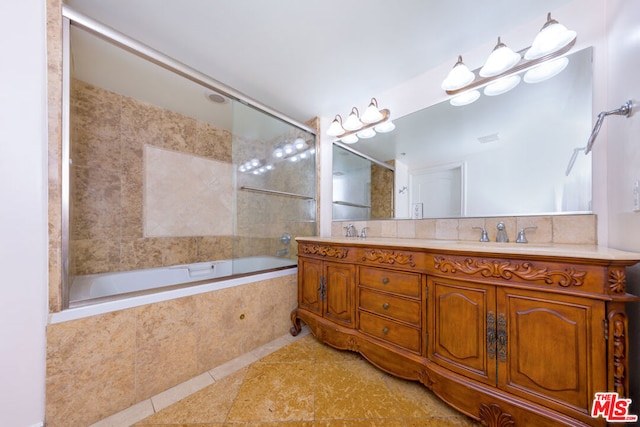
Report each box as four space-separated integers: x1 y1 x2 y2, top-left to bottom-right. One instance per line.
0 0 47 427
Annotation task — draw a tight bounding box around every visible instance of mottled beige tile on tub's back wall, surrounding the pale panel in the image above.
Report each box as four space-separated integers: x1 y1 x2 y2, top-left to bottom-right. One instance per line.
69 80 232 274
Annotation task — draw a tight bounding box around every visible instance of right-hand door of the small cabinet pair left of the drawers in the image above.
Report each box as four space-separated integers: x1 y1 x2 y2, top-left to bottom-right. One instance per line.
323 262 356 327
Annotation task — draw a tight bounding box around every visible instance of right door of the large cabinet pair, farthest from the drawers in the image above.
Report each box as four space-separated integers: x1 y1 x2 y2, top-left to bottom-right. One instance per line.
497 289 607 414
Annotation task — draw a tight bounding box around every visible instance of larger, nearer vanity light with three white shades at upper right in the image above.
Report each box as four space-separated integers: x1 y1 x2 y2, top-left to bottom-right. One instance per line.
442 13 576 106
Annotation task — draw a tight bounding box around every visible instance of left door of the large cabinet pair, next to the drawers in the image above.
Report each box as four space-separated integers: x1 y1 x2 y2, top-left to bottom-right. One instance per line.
428 277 496 385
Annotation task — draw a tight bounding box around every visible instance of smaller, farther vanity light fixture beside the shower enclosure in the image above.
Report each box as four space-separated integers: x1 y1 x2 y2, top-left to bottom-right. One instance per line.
327 98 395 144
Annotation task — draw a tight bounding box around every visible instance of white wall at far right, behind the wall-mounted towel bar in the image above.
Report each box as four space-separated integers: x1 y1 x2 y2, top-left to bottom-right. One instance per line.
596 0 640 414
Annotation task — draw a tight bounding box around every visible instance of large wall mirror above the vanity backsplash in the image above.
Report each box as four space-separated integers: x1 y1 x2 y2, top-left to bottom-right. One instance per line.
334 48 592 220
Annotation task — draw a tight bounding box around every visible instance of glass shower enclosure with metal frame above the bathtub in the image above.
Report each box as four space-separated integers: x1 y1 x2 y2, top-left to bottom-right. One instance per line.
63 10 317 307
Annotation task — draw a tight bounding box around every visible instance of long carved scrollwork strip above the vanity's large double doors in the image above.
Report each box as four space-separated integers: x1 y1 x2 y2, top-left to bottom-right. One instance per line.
433 257 587 287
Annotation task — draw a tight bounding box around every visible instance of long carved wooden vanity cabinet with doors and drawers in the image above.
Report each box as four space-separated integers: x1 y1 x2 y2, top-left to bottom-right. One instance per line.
291 238 640 427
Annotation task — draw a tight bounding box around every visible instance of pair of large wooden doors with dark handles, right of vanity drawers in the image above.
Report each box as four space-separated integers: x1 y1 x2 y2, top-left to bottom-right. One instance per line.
429 277 607 421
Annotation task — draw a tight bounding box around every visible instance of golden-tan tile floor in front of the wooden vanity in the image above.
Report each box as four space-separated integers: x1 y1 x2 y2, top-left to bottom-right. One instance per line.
135 335 480 427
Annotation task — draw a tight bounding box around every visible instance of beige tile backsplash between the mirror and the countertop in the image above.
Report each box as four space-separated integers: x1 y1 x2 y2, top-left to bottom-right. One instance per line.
331 214 597 245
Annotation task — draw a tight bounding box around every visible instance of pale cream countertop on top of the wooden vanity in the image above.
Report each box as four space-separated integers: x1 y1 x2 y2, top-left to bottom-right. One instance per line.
296 236 640 264
